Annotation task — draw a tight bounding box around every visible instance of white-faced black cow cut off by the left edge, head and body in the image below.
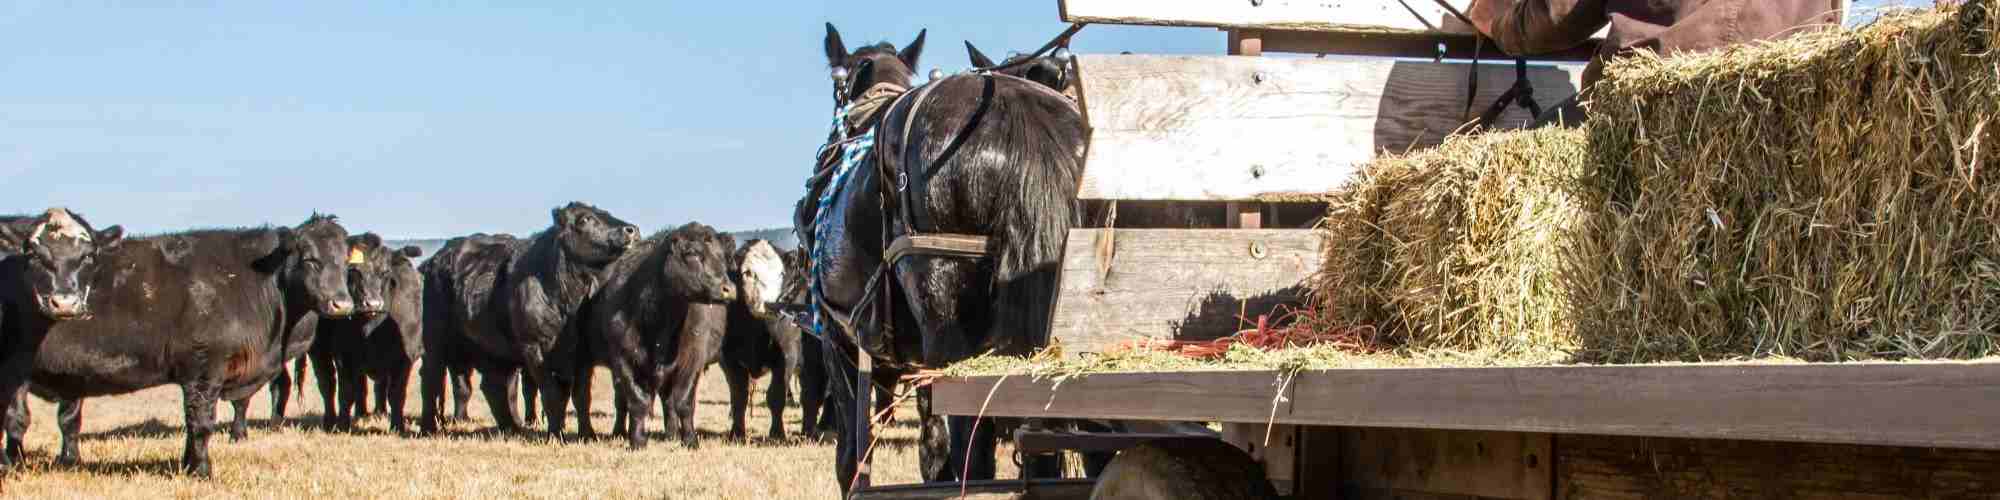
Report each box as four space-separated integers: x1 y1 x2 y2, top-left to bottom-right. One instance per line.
0 208 124 466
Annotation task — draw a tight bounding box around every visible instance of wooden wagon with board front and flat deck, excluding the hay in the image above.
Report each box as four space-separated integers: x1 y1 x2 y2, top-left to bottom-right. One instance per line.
858 0 2000 498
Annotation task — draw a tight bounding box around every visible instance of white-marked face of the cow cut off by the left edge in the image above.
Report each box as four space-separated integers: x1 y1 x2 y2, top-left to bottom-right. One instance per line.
0 208 124 320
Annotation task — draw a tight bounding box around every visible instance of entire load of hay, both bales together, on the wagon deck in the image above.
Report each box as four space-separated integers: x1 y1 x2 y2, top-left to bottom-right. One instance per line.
1318 0 2000 362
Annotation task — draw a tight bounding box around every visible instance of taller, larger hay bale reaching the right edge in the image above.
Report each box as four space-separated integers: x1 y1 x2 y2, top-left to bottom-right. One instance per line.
1570 0 2000 362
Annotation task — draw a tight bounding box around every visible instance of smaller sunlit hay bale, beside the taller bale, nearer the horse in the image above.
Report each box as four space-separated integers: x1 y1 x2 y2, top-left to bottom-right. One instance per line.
1314 128 1586 356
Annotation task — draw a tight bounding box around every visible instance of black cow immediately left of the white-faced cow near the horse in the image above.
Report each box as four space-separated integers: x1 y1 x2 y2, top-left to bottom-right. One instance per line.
584 224 736 448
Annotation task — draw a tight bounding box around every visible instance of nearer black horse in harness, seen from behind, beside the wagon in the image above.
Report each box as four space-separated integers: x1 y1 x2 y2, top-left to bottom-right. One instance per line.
796 24 1084 490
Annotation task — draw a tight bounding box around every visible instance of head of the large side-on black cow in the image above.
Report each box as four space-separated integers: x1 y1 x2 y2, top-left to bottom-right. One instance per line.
264 214 356 318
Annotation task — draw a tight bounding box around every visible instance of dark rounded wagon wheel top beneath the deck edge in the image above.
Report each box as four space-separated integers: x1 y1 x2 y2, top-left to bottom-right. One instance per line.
1090 440 1278 500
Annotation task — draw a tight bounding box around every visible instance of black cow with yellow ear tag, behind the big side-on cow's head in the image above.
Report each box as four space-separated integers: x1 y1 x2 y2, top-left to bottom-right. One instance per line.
298 234 424 432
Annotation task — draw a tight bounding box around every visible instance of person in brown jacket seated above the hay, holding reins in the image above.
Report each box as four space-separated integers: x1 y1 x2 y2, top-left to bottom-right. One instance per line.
1466 0 1842 124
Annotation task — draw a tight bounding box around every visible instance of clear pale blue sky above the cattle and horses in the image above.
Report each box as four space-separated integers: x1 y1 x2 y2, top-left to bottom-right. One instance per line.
0 0 1920 236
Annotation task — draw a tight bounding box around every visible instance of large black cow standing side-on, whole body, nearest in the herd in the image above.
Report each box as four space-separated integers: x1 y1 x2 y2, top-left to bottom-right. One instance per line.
0 214 354 476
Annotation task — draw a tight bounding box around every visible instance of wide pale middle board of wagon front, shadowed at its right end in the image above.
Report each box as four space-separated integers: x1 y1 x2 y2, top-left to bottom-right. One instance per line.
1078 56 1582 200
